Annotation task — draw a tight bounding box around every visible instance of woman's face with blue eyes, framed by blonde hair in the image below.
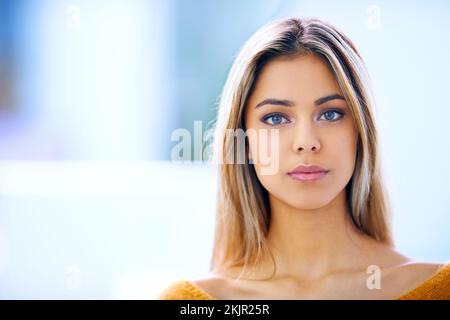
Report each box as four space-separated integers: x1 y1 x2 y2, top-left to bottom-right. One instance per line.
245 54 358 209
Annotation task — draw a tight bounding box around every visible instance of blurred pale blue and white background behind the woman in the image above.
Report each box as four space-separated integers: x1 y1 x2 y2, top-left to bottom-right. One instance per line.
0 0 450 299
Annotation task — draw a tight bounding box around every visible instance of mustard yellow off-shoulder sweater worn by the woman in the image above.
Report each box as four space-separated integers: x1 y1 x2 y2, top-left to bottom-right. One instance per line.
158 262 450 300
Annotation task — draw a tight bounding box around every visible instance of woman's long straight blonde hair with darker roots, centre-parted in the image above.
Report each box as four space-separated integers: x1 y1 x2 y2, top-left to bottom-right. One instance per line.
210 18 393 282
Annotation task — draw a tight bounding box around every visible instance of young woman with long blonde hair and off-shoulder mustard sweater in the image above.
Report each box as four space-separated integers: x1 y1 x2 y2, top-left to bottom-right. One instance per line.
160 18 450 299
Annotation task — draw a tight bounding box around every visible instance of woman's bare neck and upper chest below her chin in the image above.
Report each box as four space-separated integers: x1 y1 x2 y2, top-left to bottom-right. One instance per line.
267 192 390 280
